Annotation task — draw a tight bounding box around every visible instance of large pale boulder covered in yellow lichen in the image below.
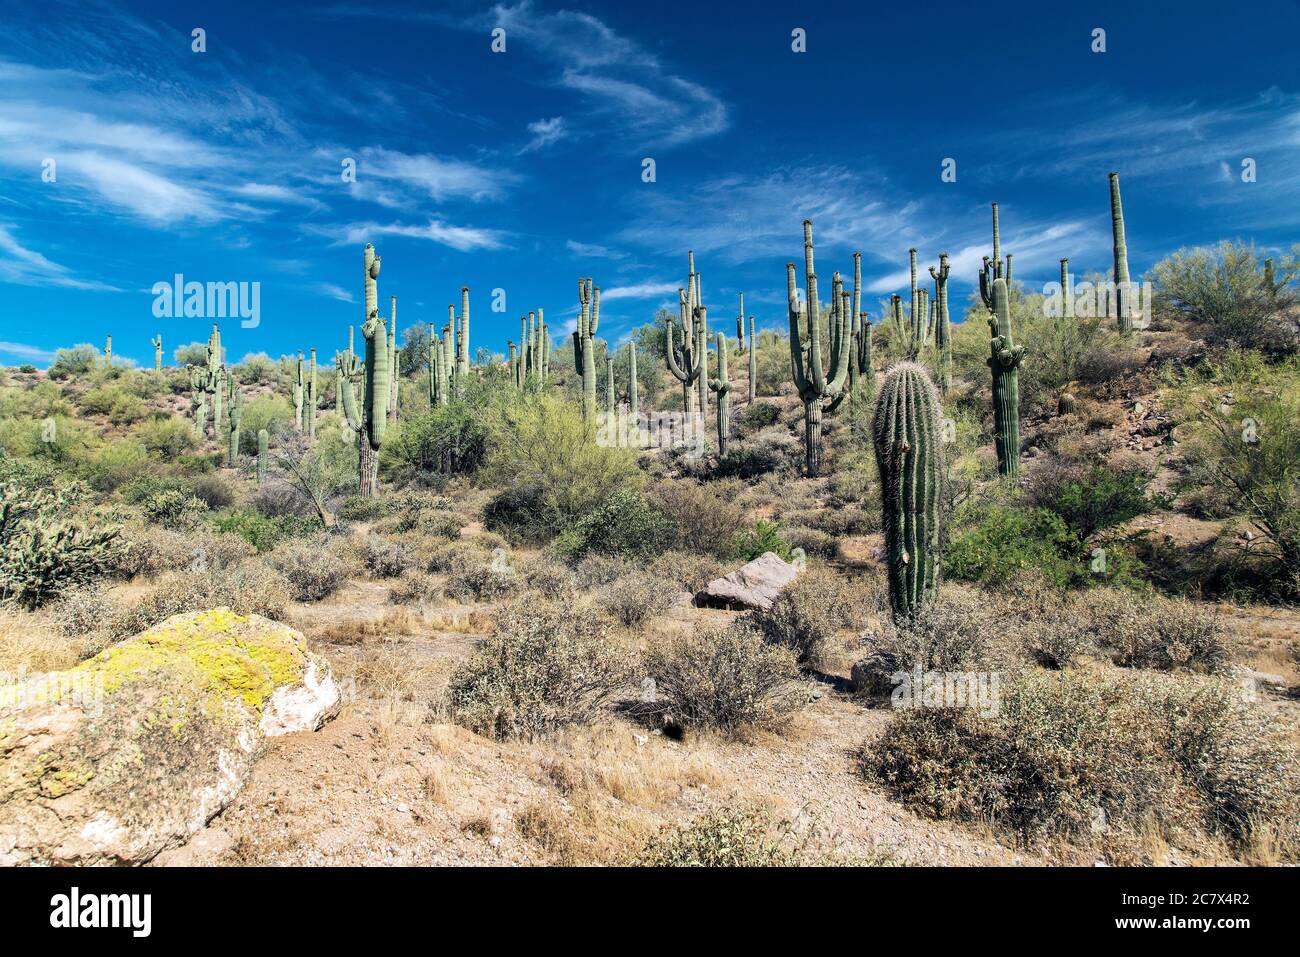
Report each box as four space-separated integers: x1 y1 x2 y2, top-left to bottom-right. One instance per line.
0 609 339 865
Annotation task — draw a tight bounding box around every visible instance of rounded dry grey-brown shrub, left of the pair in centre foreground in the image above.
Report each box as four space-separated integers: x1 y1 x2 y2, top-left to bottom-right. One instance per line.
447 597 631 739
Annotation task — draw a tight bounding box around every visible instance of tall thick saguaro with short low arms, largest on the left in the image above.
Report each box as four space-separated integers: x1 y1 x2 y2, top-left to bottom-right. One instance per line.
334 243 387 497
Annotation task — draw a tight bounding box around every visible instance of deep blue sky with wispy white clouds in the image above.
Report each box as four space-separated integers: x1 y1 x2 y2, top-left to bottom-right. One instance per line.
0 0 1300 364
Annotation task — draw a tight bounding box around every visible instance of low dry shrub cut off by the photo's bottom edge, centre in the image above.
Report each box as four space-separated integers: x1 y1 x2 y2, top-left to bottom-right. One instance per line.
637 809 798 867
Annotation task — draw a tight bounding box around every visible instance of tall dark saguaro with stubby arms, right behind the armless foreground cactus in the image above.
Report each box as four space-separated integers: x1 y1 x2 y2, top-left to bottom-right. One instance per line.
979 203 1024 477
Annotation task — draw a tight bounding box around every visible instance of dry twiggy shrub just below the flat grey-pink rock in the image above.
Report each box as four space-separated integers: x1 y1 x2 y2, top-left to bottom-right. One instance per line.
645 623 809 732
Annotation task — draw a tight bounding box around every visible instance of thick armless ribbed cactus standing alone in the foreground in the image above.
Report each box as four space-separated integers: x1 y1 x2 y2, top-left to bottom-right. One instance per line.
871 361 944 619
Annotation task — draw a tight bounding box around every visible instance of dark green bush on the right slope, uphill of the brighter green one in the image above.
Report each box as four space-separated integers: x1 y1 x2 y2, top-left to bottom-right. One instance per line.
1027 460 1167 541
